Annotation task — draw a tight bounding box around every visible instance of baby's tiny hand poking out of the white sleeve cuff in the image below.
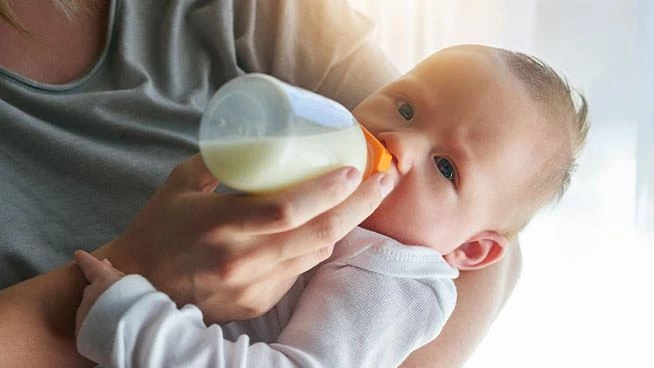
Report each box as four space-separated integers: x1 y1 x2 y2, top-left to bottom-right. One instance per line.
74 250 125 336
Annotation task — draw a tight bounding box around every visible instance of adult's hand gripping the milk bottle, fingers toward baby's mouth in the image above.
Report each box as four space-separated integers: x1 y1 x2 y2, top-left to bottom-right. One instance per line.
96 155 393 322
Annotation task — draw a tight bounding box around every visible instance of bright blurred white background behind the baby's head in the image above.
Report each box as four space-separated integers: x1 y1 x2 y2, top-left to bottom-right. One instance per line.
350 0 654 368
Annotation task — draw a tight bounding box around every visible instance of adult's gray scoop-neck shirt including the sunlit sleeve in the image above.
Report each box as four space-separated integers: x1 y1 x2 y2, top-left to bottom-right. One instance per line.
0 0 396 288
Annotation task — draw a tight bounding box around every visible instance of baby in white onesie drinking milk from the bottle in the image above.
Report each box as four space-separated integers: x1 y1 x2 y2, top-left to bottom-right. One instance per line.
75 45 588 367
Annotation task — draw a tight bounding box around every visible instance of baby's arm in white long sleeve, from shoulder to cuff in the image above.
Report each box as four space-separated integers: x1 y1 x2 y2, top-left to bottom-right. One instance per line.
73 247 451 367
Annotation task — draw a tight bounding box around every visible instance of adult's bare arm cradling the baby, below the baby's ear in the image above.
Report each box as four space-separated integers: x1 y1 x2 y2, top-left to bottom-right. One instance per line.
402 242 522 368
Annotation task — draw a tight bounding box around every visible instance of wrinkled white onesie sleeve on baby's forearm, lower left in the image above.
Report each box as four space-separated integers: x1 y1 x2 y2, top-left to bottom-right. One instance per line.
77 275 299 368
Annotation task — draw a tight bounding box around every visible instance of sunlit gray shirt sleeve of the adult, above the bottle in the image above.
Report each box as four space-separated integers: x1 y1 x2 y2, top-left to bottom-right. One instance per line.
235 0 398 109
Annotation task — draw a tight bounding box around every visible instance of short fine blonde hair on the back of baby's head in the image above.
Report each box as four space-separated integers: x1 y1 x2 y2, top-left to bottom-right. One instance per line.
500 50 590 239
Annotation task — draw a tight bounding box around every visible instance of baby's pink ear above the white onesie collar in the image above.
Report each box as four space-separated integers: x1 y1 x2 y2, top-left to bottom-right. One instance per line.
444 231 508 271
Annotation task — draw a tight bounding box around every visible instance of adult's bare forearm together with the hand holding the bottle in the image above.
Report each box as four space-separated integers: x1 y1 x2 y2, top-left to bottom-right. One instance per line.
0 155 392 367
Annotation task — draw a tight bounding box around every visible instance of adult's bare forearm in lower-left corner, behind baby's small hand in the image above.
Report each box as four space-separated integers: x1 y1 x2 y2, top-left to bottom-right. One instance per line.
0 263 93 367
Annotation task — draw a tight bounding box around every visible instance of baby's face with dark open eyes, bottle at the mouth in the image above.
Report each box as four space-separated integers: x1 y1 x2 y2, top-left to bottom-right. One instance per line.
354 46 543 254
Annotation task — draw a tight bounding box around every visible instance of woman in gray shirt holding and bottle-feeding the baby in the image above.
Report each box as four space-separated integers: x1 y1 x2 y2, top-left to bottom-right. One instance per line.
0 0 520 367
